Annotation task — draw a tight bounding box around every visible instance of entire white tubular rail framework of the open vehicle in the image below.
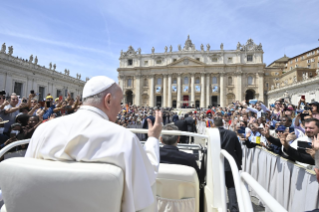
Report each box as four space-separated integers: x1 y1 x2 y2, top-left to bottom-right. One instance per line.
0 128 286 212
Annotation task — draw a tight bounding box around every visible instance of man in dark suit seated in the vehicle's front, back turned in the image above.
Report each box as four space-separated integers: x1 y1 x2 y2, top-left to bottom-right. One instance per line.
160 123 199 176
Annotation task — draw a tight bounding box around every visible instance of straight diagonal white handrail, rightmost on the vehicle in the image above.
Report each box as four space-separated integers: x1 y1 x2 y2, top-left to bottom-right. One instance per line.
240 172 287 212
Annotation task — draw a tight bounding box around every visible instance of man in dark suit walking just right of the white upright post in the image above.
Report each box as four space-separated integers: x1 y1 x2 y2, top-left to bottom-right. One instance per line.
214 117 243 212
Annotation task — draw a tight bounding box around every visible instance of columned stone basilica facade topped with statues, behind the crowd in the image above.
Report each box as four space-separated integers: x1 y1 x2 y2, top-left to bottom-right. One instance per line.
117 36 265 108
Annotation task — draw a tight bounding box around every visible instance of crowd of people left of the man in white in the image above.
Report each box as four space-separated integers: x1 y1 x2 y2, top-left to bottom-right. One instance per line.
0 90 82 156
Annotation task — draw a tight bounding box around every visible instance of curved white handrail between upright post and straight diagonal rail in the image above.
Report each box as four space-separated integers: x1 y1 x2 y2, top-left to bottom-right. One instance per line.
220 149 253 212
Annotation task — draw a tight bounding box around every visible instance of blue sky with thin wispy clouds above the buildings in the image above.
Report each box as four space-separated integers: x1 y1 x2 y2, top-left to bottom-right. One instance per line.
0 0 319 80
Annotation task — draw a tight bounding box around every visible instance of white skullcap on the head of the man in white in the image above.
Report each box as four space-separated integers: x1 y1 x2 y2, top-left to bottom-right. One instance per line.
82 76 115 99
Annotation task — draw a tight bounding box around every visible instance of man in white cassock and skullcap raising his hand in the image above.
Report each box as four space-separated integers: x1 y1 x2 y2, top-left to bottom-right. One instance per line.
25 76 162 212
